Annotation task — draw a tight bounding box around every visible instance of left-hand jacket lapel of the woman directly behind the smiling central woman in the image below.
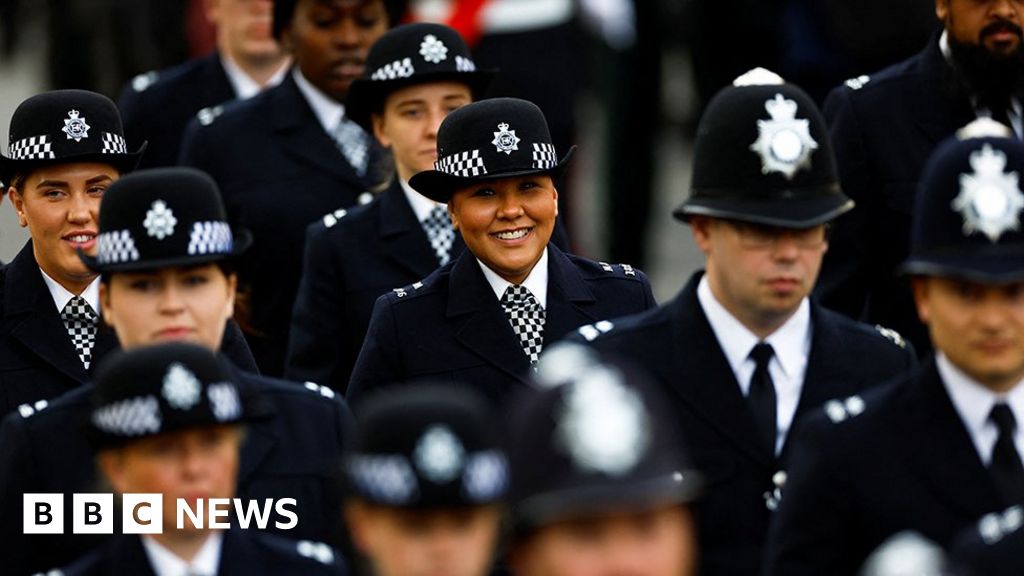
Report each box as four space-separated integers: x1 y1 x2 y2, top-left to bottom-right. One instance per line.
378 176 448 278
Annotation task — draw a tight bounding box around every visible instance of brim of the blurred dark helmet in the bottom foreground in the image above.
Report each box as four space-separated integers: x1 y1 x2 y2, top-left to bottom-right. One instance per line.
514 470 705 531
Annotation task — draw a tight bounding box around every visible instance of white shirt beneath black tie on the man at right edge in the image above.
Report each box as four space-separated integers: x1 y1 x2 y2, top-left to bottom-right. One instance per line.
935 352 1024 466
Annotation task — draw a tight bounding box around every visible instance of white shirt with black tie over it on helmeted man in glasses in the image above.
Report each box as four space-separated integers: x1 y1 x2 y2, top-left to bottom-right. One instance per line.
697 276 812 454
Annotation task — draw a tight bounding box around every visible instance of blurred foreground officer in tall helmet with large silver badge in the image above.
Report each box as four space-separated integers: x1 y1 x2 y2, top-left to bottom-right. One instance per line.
508 342 702 576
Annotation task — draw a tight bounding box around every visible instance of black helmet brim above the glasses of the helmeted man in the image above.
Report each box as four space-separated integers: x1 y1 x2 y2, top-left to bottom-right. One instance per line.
672 186 854 230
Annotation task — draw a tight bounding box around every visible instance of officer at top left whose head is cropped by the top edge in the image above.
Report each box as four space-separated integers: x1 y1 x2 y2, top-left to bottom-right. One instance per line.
118 0 290 168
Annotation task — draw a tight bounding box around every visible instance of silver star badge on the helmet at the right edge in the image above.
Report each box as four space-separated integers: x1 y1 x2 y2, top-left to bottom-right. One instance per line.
951 143 1024 242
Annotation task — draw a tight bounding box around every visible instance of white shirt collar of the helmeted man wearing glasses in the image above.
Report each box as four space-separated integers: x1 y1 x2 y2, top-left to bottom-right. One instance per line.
697 276 811 379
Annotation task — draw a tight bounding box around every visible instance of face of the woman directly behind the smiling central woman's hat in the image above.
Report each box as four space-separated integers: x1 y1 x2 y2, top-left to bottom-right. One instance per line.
373 82 473 181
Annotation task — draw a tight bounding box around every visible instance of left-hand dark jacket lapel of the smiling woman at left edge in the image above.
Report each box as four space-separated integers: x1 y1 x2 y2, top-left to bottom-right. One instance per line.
4 240 89 383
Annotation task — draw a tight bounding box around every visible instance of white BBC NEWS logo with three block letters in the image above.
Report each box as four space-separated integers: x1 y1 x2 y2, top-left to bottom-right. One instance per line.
23 494 299 534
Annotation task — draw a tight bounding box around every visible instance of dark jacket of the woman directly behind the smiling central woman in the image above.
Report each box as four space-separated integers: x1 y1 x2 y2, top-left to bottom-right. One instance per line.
285 177 465 392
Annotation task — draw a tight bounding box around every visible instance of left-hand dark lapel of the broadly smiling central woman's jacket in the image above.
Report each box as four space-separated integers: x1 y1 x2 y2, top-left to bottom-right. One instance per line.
445 250 529 382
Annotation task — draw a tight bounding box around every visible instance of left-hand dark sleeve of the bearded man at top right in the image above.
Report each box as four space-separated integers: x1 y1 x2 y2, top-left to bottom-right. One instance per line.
815 86 872 319
